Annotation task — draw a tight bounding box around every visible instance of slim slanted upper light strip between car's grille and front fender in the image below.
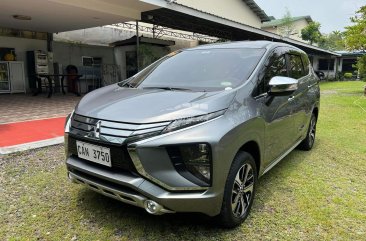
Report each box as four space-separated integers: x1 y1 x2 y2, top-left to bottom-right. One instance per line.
162 110 225 134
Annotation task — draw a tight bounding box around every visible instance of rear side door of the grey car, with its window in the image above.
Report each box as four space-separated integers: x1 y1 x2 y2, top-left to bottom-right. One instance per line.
287 50 309 141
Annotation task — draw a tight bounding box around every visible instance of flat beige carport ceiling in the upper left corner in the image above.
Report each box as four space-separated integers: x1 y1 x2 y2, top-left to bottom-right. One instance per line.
0 0 158 33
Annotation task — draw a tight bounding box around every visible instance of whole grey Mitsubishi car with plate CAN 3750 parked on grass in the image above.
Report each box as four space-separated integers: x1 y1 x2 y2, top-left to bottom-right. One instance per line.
65 41 320 227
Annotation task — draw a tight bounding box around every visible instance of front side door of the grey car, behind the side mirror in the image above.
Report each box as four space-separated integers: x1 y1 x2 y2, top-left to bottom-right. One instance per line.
256 47 294 166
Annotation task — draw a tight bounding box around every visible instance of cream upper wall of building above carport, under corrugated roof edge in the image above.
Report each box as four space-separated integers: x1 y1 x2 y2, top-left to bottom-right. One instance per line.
177 0 261 28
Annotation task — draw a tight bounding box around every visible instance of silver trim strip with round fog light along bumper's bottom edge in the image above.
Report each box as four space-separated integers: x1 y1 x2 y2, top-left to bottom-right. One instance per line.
68 172 175 214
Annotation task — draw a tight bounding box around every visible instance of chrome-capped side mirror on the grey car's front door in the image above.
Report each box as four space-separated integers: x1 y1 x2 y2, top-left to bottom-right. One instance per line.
269 76 299 95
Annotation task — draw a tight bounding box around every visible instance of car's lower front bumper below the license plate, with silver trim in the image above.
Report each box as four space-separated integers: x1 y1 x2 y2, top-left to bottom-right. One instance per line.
66 156 221 216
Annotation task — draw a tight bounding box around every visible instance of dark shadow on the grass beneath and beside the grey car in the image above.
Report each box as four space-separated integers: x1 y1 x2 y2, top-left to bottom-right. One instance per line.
77 143 319 239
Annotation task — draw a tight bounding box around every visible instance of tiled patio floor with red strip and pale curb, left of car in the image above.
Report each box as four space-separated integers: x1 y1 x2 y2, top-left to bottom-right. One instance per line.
0 94 81 155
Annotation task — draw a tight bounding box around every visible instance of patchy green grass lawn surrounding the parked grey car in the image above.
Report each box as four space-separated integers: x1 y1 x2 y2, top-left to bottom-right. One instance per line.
0 82 366 240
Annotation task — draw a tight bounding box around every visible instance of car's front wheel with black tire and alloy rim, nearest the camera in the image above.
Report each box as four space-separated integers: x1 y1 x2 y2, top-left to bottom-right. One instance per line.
218 152 258 228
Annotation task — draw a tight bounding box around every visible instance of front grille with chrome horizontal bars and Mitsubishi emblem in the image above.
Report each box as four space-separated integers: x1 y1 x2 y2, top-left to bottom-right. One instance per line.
70 114 170 144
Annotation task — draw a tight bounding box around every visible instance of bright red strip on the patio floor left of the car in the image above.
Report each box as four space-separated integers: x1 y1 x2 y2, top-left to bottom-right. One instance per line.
0 117 65 147
